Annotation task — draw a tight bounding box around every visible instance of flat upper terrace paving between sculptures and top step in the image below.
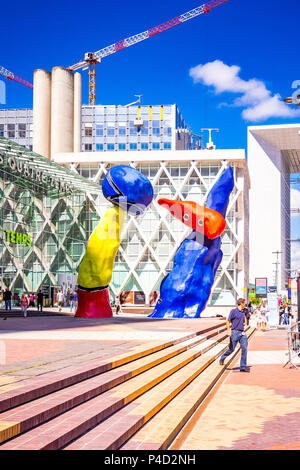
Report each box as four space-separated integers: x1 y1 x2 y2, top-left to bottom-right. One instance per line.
0 314 220 393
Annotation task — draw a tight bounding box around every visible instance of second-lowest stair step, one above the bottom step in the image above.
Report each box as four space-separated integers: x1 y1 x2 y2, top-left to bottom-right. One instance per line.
65 344 227 450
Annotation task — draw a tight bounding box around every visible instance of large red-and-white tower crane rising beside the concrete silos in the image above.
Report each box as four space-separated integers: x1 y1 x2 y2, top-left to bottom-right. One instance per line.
68 0 229 106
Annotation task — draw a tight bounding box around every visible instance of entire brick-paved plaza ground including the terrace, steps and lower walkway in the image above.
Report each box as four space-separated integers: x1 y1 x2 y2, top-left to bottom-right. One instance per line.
0 312 300 450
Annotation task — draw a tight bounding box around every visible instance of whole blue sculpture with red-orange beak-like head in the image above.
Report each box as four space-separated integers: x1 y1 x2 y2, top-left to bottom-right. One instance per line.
149 167 234 318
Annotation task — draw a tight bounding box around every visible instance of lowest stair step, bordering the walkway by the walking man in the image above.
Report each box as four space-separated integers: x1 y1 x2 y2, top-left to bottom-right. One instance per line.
120 328 255 451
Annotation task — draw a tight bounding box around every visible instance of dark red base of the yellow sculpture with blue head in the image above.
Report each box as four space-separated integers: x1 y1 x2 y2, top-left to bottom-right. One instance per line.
75 287 113 318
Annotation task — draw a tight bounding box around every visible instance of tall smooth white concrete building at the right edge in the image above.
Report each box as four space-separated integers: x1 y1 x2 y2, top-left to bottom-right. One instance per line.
248 124 300 291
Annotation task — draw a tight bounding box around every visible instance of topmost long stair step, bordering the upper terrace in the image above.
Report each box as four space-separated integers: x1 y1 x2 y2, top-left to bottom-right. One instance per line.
0 323 224 413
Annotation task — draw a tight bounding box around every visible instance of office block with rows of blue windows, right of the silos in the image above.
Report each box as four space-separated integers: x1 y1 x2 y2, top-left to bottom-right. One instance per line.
82 105 200 152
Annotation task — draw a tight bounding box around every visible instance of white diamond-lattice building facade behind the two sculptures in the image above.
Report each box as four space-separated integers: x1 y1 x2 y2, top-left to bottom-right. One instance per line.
54 150 250 313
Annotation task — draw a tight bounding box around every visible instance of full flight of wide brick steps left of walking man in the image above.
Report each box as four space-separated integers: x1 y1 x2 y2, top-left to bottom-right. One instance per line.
0 322 252 450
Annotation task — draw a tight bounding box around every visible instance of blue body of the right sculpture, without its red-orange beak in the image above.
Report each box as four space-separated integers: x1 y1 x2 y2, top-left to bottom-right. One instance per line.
149 167 234 318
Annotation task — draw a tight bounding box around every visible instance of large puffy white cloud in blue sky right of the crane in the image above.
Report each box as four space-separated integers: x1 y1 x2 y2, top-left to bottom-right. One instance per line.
190 60 300 122
